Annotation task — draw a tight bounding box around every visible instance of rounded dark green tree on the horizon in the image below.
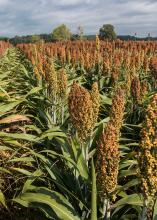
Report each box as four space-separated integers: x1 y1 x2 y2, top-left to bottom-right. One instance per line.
99 24 116 40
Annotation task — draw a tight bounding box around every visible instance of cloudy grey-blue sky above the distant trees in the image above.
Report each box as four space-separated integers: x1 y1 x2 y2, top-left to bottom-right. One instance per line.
0 0 157 36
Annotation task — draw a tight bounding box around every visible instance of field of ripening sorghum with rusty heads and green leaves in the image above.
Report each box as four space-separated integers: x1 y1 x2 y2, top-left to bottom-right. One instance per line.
0 37 157 220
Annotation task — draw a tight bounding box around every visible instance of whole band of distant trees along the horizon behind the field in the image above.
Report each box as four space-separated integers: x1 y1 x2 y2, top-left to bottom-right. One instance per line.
0 24 157 45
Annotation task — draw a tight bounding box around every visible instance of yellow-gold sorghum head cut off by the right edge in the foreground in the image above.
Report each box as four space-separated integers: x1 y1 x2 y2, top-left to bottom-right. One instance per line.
138 94 157 198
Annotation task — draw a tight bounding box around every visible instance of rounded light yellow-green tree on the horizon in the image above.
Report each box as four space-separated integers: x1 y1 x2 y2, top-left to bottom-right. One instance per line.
52 24 72 41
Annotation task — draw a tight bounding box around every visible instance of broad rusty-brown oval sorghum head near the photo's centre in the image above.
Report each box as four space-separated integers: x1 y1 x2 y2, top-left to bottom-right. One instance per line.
68 82 93 141
